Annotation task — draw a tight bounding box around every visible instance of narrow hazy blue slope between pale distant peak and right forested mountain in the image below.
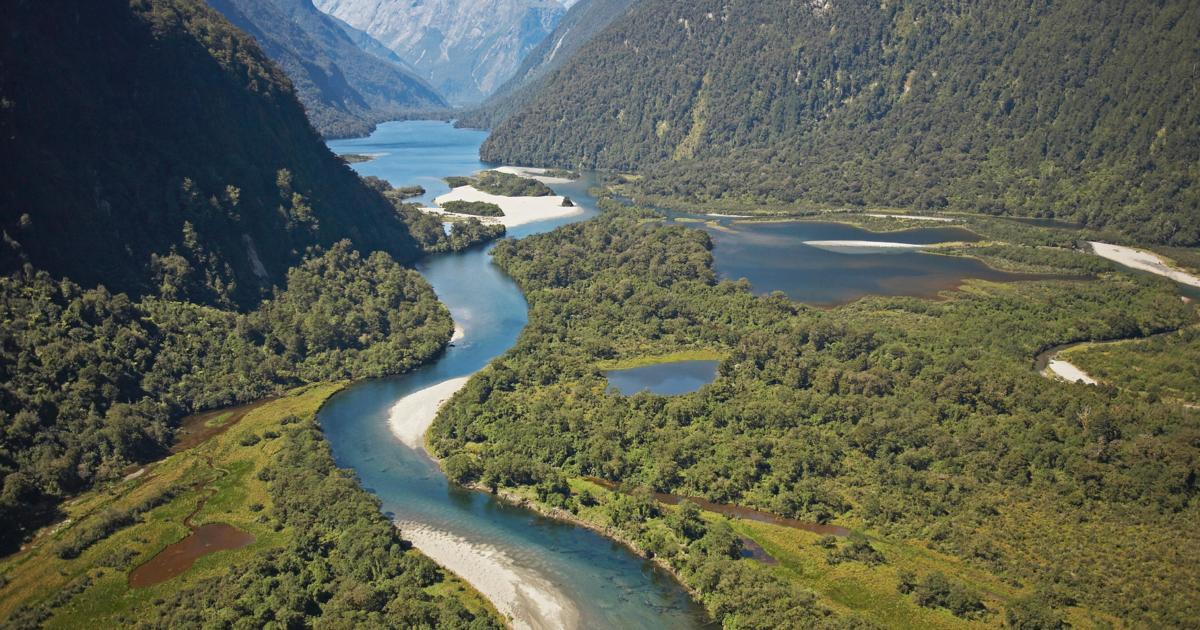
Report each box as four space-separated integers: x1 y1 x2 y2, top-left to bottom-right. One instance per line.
458 0 636 128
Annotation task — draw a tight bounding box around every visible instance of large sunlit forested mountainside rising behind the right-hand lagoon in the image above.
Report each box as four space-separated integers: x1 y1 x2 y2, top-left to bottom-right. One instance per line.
482 0 1200 245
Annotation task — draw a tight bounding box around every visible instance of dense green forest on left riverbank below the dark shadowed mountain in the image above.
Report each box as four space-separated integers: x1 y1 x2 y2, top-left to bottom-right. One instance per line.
0 242 452 548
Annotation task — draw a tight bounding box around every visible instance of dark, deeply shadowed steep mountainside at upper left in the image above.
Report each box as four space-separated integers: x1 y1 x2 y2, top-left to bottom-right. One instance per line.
0 0 418 306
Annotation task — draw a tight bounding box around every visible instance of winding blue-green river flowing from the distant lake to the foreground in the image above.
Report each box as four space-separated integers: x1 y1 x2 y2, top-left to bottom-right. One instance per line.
319 121 707 629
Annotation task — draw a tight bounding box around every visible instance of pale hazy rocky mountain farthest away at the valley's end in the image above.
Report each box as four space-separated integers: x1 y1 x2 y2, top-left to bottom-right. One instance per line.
316 0 565 104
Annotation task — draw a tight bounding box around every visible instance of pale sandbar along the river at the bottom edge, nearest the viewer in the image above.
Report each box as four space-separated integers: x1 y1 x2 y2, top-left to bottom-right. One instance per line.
396 521 580 630
